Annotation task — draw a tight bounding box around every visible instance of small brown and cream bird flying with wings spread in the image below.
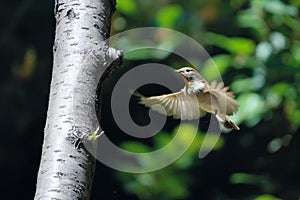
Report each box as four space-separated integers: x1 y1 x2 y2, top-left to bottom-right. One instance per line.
134 67 240 130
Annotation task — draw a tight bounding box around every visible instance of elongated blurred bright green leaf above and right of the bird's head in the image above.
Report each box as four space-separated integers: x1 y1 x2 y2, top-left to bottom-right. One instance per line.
206 33 255 55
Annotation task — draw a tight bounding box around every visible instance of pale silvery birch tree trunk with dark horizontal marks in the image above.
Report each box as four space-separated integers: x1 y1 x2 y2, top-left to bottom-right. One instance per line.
35 0 120 200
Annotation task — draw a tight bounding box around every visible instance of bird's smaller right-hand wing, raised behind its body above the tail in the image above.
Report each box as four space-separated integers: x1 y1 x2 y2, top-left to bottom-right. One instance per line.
203 81 239 115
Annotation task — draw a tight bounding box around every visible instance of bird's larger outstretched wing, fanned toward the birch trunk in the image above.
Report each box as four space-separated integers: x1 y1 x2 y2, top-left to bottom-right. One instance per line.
134 91 206 120
